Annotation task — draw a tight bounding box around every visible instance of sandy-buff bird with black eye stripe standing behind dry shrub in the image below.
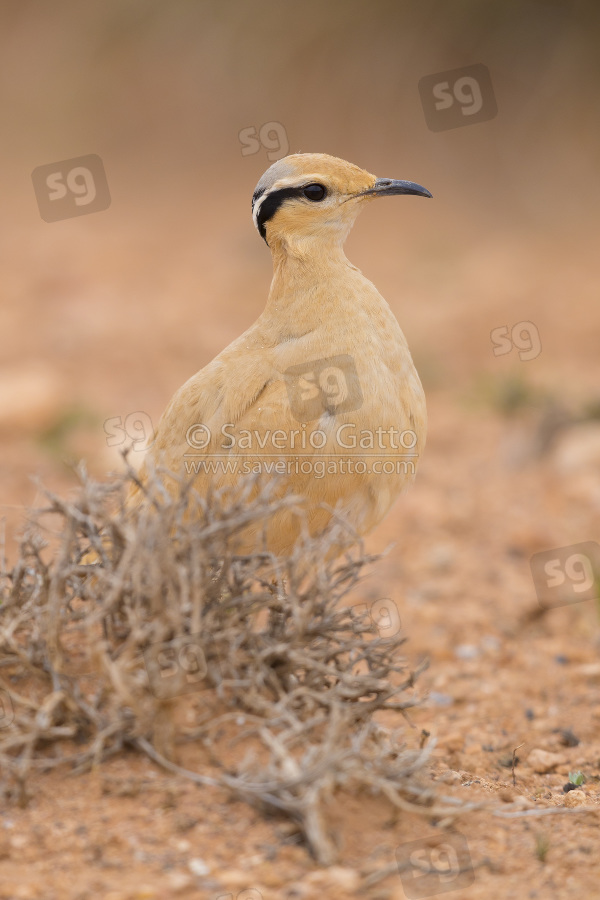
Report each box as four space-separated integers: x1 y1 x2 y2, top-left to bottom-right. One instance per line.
129 153 432 556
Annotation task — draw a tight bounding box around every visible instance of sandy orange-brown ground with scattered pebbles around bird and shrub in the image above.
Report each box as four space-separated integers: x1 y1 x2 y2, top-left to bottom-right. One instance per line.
0 186 600 900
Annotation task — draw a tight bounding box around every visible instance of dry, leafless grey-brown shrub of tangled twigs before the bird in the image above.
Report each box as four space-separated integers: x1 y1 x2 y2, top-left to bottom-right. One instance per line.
0 469 451 863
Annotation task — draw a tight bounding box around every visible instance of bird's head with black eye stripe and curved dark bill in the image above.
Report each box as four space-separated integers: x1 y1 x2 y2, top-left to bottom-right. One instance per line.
252 153 431 252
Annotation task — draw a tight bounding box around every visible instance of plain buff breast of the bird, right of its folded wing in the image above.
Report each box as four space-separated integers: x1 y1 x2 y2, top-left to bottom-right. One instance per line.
264 305 426 534
